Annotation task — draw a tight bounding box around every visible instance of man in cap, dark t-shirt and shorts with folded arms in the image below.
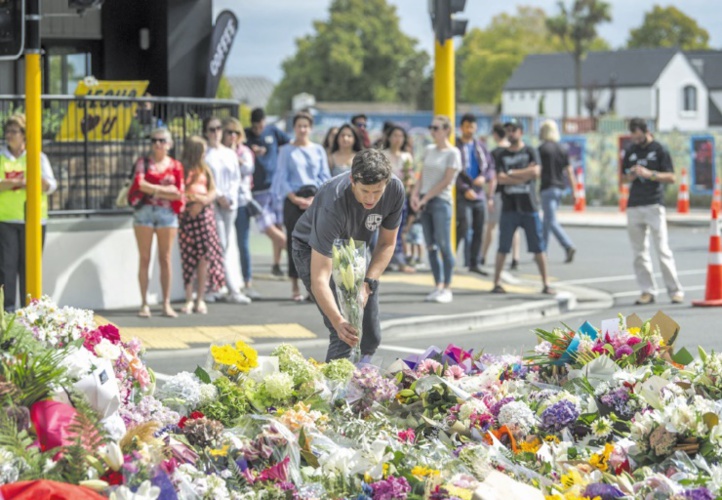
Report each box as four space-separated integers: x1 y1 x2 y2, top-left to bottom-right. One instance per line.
492 119 555 295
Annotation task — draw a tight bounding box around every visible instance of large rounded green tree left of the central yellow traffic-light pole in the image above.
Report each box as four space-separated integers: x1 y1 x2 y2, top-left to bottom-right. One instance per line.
272 0 429 111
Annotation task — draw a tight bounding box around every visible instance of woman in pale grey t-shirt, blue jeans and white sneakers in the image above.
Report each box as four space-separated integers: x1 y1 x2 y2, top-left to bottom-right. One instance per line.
411 115 461 304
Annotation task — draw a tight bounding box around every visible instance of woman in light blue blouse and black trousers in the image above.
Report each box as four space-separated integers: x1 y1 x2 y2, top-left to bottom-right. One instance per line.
271 111 331 302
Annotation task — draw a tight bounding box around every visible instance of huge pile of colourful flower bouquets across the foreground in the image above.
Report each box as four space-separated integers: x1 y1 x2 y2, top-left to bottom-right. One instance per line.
0 298 722 499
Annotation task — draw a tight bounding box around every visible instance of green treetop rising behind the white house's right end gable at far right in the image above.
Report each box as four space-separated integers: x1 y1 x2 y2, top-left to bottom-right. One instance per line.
627 5 710 50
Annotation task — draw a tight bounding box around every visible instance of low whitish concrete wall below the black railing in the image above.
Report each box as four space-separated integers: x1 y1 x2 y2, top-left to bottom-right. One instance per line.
43 217 241 310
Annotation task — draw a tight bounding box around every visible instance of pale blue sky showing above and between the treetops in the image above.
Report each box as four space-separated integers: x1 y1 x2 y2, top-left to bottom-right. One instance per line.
213 0 722 83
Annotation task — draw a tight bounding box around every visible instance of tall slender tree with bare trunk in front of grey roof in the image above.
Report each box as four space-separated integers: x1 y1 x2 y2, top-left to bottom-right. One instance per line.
547 0 612 116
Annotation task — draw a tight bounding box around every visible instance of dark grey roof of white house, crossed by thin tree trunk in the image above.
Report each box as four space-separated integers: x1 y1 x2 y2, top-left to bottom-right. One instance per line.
504 48 678 90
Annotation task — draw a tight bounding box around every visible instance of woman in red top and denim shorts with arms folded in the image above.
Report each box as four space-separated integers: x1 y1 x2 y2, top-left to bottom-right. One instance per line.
129 128 185 318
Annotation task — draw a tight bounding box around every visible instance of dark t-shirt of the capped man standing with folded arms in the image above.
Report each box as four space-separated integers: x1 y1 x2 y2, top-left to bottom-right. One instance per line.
496 145 539 213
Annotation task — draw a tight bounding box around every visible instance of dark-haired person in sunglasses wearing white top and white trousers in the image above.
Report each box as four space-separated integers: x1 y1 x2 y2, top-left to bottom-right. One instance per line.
203 116 251 304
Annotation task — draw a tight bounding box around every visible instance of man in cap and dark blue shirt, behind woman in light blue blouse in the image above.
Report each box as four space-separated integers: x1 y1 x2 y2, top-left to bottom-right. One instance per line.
246 108 290 277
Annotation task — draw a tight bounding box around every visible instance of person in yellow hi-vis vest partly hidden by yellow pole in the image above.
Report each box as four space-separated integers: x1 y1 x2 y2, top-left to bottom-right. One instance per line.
0 114 58 312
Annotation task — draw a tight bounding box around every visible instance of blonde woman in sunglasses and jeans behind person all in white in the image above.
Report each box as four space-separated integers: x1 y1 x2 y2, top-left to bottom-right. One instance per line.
222 117 261 300
